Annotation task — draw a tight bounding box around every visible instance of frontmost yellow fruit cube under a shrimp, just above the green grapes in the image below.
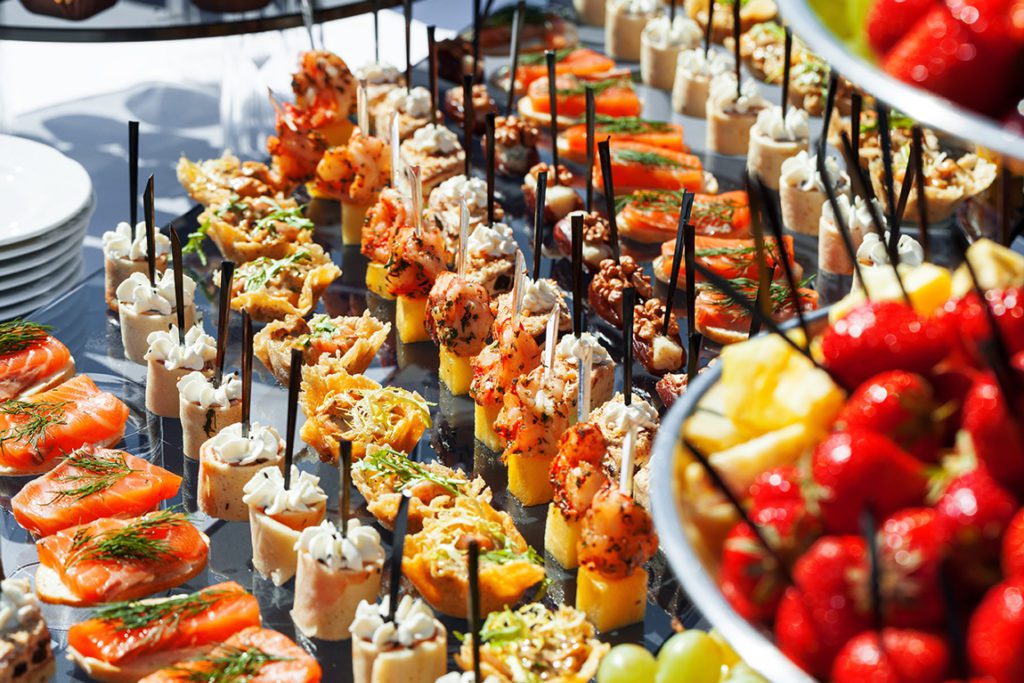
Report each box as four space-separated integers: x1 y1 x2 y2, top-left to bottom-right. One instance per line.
577 565 647 633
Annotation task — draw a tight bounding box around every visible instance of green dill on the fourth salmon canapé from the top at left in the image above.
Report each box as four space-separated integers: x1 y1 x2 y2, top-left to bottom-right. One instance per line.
68 510 186 567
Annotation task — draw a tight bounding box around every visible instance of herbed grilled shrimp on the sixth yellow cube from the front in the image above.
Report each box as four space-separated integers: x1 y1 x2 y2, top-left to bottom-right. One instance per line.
385 225 447 297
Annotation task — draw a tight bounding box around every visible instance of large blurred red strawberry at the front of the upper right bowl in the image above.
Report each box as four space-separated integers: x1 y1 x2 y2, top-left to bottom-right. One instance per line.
882 0 1024 116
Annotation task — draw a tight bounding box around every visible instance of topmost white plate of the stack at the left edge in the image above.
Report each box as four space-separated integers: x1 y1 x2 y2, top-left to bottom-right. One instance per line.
0 135 92 246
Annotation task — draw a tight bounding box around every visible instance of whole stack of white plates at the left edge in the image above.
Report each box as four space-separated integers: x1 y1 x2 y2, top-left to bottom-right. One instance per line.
0 135 95 321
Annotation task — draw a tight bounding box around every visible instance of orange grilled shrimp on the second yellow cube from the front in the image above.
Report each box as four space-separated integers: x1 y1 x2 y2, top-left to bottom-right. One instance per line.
550 422 608 519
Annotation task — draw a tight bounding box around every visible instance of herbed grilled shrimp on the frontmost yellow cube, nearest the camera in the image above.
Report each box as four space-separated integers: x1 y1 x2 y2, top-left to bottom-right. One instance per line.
579 481 657 578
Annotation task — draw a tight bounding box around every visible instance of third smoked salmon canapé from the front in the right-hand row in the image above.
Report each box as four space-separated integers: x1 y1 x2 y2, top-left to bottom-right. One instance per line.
616 186 751 244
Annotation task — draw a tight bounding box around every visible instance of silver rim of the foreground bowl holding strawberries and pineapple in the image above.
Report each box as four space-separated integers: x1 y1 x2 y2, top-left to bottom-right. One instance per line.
650 307 828 683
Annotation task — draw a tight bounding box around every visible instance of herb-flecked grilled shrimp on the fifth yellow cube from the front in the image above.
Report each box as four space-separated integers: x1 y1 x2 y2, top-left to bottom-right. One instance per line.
427 272 495 356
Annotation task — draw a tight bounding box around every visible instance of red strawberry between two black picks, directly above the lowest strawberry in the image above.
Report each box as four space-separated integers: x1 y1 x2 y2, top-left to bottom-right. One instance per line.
879 508 946 628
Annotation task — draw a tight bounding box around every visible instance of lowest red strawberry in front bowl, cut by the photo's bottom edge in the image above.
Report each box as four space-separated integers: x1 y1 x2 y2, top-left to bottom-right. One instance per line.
831 629 949 683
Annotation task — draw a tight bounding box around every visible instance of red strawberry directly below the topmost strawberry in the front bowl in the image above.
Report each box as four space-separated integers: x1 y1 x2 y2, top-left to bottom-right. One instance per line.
838 370 943 462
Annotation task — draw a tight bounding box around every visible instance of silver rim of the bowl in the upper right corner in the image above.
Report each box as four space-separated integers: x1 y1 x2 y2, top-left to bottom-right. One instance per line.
776 0 1024 161
